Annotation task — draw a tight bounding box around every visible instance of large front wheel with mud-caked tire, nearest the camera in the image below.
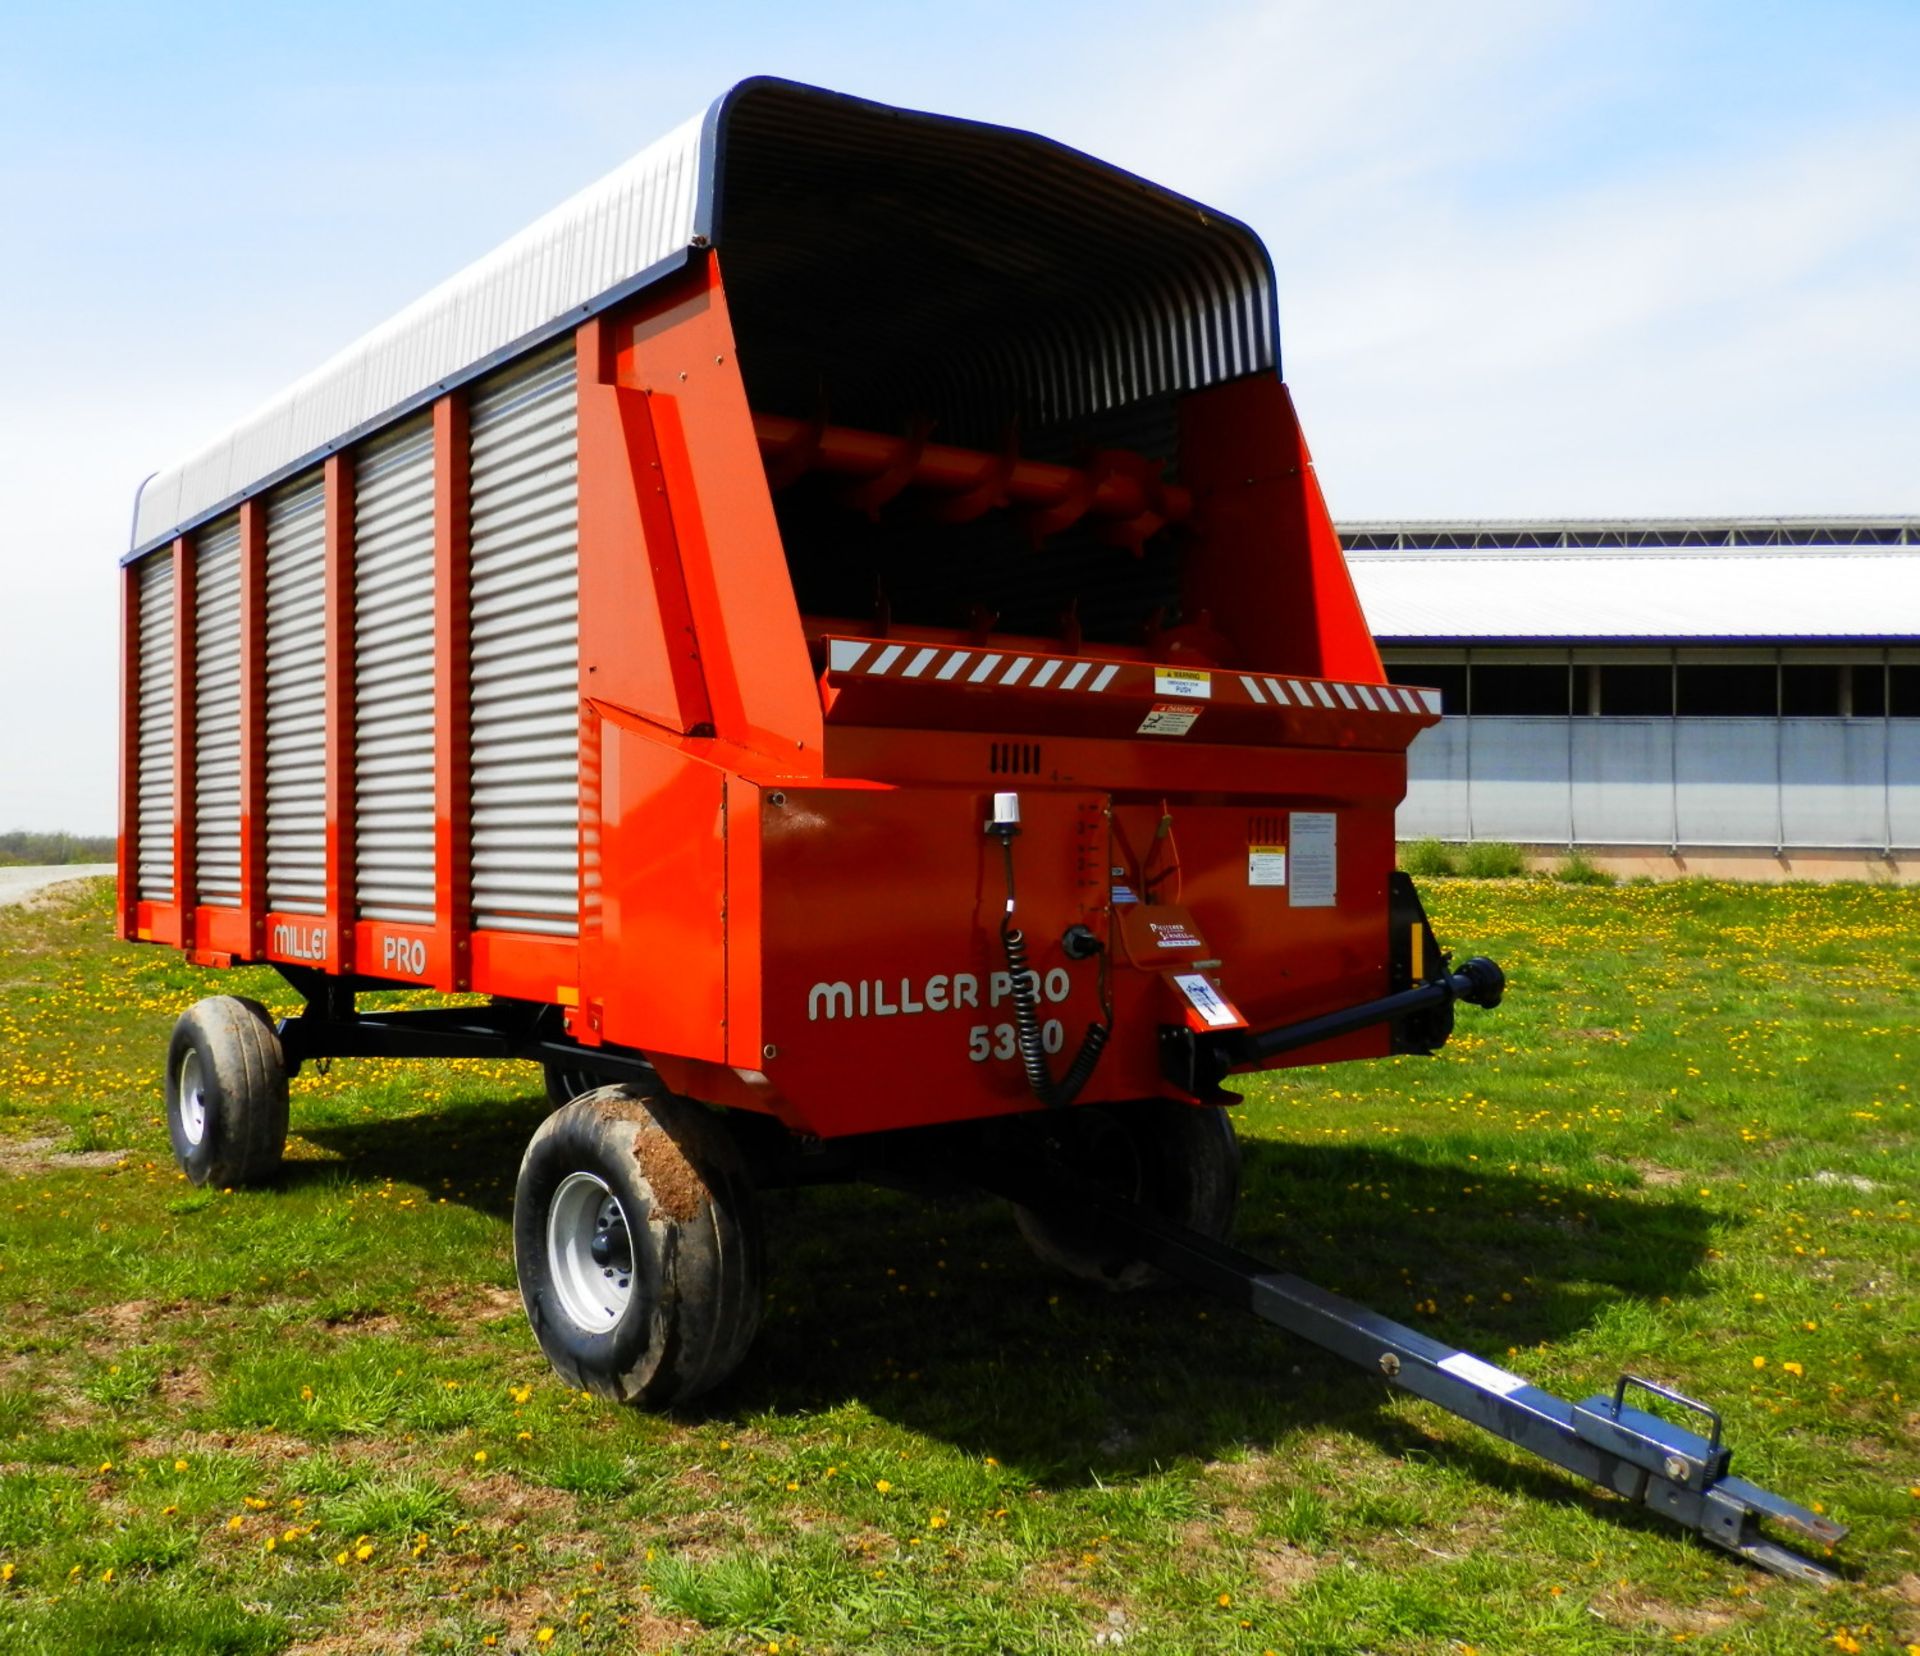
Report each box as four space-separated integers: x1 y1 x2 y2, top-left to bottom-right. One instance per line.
513 1086 764 1408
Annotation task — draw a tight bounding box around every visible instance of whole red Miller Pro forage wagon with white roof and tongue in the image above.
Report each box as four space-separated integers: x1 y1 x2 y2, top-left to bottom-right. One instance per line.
119 81 1839 1573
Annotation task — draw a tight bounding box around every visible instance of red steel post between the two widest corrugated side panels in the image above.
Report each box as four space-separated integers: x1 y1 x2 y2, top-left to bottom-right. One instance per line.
434 391 472 990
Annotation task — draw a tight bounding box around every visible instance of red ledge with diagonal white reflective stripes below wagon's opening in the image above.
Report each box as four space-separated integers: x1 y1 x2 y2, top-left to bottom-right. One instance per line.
820 633 1440 752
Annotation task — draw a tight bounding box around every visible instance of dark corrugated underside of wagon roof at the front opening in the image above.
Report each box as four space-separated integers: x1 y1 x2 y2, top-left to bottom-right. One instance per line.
714 83 1279 443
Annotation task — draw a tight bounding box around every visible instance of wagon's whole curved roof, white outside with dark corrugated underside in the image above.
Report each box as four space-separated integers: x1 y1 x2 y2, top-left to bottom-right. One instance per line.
129 77 1279 556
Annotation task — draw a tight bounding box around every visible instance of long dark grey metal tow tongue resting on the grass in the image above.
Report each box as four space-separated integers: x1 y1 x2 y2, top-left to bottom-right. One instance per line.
977 1157 1847 1587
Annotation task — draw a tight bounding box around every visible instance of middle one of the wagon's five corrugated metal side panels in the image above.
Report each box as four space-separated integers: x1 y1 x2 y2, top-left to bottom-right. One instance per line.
267 472 326 913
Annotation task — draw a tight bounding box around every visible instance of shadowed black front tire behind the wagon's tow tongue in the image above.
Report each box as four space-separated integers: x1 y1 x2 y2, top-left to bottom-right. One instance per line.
1014 1098 1240 1289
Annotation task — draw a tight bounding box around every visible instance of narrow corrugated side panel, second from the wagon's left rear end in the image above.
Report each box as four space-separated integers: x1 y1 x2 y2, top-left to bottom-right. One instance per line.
194 516 240 908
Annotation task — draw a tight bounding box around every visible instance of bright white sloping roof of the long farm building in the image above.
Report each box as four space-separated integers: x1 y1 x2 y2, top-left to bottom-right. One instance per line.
1346 547 1920 645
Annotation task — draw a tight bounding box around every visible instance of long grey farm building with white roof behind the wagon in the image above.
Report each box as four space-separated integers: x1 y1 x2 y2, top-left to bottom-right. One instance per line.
1342 518 1920 875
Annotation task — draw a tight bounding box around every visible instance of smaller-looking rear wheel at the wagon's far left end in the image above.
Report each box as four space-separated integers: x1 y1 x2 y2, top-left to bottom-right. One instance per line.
167 994 286 1188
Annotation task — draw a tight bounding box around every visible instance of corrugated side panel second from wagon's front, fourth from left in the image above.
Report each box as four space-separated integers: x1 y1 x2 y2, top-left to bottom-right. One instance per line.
353 420 434 925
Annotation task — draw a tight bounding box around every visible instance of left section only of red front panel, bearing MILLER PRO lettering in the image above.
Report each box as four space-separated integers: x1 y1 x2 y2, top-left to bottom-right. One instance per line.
735 787 1113 1136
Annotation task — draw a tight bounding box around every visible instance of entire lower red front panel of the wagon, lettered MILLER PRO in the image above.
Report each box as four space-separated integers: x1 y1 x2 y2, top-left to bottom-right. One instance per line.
725 771 1392 1136
